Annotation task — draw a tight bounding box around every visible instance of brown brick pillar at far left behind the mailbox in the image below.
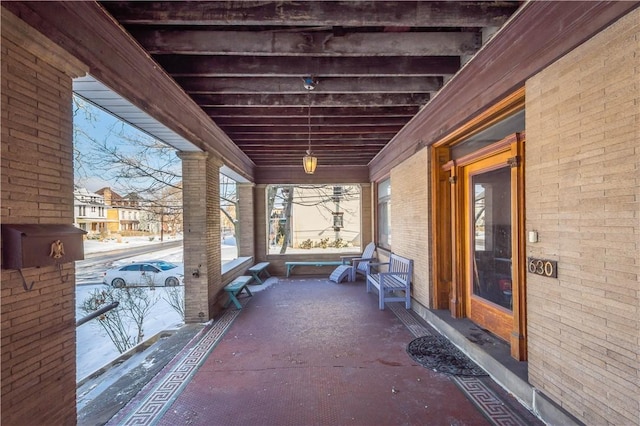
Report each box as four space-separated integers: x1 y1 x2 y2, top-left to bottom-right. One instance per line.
1 9 82 425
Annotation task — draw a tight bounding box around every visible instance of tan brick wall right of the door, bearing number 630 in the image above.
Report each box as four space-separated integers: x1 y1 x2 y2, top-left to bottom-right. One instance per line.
526 9 640 425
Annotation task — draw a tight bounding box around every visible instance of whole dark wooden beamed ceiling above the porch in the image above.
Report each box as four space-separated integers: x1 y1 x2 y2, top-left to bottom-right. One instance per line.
101 1 522 167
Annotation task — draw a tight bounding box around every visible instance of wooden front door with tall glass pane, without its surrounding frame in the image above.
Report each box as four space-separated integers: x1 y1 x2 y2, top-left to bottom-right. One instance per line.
462 151 515 341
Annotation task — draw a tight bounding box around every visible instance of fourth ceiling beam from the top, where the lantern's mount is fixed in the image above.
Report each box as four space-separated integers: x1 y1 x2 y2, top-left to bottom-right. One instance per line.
176 76 443 95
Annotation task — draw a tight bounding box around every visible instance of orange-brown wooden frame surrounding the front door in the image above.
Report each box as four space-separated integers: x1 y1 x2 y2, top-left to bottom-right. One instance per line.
431 87 527 361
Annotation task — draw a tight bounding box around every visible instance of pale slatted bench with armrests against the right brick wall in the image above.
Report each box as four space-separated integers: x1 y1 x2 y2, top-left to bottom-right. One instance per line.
367 253 413 310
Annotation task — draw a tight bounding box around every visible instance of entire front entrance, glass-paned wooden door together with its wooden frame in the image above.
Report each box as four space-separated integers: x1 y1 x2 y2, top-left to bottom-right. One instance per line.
431 88 527 361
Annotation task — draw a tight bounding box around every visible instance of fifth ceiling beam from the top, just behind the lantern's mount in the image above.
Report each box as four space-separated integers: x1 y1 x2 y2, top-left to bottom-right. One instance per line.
192 93 430 106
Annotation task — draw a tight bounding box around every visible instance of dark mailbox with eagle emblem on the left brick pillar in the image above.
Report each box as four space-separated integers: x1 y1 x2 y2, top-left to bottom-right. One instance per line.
2 224 86 269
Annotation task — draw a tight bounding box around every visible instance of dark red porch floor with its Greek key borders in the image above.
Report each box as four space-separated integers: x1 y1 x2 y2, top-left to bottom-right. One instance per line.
109 278 542 426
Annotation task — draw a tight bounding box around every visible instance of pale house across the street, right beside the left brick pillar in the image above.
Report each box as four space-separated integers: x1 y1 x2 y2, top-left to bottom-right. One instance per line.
73 188 112 235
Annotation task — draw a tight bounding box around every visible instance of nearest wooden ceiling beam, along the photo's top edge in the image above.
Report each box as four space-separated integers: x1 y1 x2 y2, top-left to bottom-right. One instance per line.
102 1 519 27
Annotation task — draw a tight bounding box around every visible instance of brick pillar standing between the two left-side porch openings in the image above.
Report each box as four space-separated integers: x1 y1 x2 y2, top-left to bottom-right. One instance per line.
179 152 222 322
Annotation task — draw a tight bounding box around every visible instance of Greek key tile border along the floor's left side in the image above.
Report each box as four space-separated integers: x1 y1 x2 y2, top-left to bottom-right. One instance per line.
114 301 246 425
